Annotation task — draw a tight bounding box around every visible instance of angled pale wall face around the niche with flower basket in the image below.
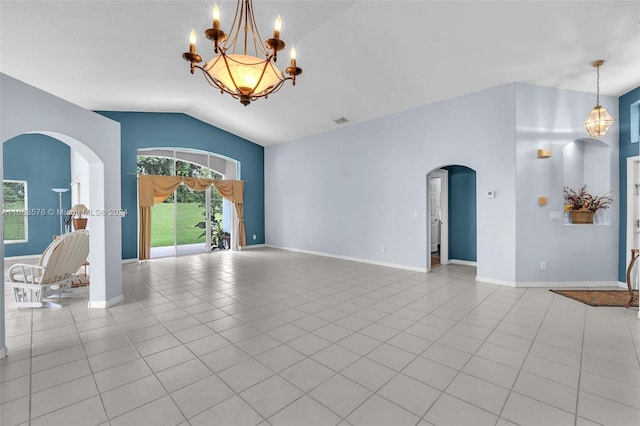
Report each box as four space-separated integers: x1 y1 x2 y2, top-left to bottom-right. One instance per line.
516 84 620 286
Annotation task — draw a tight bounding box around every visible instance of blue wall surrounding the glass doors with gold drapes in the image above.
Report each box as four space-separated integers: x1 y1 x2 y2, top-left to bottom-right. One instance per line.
97 111 265 259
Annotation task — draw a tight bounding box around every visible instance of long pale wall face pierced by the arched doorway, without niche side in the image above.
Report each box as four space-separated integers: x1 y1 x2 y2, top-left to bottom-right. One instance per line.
265 85 516 282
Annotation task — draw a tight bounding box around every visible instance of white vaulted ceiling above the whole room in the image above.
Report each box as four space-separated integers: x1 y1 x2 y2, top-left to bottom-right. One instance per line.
0 0 640 146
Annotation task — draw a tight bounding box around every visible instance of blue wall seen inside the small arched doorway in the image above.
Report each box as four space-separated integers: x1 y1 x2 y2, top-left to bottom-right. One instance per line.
445 166 478 262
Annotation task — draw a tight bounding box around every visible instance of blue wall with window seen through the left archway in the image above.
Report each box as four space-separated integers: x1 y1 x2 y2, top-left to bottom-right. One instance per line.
2 134 71 257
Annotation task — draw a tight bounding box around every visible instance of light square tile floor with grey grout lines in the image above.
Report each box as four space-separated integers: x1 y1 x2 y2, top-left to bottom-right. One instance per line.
0 248 640 426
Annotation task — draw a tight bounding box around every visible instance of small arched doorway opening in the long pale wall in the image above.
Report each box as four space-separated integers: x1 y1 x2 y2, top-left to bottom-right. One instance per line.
426 165 477 270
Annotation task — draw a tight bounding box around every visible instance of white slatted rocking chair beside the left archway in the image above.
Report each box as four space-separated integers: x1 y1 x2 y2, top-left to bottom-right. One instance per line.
4 229 89 308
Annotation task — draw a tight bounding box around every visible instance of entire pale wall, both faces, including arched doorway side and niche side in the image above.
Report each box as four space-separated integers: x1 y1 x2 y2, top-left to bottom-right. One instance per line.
265 84 619 286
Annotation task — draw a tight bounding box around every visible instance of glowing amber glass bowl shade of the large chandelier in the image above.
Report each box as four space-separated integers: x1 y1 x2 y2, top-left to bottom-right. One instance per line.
205 54 285 97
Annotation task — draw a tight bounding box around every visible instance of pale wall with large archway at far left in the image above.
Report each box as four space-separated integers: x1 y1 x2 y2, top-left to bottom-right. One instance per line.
0 73 122 356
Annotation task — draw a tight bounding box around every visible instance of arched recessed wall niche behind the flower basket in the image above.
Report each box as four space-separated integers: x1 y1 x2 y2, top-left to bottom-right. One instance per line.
562 138 611 225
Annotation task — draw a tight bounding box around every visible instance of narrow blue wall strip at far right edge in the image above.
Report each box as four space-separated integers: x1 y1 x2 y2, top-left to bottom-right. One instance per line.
618 87 640 282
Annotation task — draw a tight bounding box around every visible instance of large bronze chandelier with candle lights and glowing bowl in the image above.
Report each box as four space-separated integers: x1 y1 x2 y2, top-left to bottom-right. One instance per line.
182 0 302 106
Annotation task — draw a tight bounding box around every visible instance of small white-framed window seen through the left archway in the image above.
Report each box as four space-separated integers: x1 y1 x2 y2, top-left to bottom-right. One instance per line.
2 180 28 243
